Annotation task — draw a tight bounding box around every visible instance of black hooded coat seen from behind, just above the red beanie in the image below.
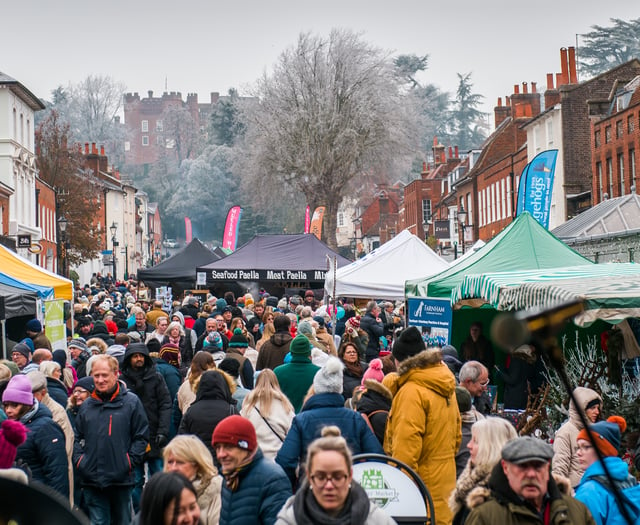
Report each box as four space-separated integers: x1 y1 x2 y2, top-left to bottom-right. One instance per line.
178 370 238 457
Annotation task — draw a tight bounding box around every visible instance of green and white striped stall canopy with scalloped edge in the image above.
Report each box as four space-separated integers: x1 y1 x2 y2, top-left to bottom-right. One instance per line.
451 263 640 326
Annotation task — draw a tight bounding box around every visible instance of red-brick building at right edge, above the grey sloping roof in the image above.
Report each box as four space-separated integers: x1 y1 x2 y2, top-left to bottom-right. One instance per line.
589 70 640 205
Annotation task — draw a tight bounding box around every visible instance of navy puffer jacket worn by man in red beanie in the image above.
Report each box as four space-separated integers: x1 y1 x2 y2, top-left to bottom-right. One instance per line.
220 449 291 525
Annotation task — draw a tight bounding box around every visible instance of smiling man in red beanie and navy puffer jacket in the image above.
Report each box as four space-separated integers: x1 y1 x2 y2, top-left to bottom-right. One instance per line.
211 415 291 525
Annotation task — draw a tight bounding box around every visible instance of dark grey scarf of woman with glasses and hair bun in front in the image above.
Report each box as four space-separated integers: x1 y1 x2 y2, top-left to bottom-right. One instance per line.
293 481 370 525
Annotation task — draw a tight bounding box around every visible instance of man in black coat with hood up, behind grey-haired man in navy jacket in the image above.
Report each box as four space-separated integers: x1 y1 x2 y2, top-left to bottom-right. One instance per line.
121 343 171 512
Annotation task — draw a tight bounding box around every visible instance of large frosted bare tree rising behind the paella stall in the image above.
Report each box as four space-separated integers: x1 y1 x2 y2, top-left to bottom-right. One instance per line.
239 30 416 248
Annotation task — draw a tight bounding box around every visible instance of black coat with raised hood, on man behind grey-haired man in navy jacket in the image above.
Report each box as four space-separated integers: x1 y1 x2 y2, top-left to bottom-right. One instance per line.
120 344 172 458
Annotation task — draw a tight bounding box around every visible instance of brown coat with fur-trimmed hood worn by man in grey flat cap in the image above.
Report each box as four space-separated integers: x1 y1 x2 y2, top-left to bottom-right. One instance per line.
465 463 595 525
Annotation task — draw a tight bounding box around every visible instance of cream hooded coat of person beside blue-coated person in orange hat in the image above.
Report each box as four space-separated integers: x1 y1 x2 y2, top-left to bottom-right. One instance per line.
551 386 602 487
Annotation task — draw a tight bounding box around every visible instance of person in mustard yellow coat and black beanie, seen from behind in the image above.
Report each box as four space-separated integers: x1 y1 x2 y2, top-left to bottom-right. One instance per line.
383 327 462 525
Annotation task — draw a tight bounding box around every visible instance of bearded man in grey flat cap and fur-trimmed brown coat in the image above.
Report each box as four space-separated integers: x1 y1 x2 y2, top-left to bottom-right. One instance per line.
465 436 595 525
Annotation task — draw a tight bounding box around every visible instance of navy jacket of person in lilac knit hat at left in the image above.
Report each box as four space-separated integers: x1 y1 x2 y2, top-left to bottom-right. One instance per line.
16 403 69 498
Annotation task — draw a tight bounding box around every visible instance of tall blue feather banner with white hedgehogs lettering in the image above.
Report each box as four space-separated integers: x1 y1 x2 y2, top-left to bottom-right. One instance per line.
518 149 558 228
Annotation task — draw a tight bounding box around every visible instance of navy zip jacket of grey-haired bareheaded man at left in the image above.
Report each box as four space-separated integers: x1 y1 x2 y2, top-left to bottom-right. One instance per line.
72 382 149 488
